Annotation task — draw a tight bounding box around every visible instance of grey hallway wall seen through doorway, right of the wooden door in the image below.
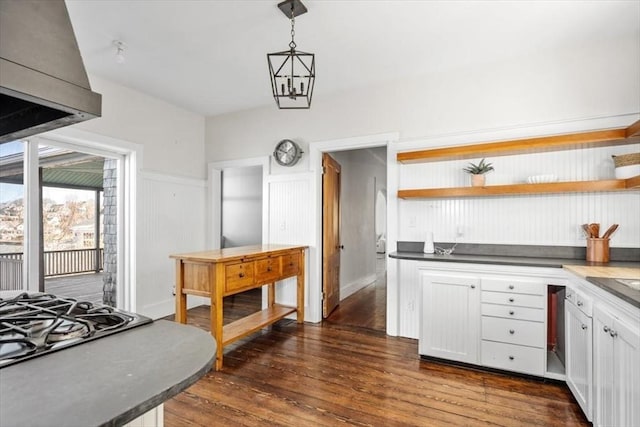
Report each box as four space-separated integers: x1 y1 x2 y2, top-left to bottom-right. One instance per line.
330 147 387 299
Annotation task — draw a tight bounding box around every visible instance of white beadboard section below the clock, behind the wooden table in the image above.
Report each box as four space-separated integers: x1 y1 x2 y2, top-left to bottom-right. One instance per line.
264 173 314 307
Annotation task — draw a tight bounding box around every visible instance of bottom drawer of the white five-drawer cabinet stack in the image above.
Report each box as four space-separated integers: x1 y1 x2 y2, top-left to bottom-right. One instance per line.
480 341 544 376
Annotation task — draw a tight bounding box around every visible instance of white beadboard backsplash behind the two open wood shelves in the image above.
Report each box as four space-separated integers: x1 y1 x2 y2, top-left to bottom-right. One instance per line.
398 144 640 247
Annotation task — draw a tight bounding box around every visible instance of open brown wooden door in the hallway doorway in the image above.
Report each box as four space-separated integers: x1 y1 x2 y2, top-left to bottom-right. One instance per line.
322 153 341 318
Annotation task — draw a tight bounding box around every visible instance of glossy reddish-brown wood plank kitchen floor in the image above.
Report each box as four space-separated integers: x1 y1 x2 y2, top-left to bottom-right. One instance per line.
164 290 589 427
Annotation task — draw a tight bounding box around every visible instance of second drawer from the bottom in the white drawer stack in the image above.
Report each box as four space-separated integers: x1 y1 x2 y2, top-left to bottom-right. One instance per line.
482 316 545 348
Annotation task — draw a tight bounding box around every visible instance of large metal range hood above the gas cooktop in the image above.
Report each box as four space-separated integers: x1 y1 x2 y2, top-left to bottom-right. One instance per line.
0 0 102 144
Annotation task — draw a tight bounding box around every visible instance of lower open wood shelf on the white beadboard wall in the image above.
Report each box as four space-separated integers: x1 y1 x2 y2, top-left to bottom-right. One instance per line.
398 175 640 199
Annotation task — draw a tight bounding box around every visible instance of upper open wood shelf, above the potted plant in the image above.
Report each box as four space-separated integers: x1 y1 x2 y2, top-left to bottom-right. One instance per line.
396 120 640 163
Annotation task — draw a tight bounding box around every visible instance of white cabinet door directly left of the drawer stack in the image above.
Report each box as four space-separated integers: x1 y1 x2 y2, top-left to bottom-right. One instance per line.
418 272 480 364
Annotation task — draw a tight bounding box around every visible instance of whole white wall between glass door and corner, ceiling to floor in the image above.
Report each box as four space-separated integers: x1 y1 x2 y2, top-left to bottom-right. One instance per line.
73 76 206 317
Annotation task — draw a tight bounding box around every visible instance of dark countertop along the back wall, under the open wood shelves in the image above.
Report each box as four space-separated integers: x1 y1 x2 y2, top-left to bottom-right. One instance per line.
389 251 640 268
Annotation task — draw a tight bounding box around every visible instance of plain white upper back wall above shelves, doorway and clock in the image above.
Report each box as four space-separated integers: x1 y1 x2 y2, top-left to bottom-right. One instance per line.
206 38 640 165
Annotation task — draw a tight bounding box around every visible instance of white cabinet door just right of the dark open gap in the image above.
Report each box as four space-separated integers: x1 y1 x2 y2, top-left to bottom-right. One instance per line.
564 301 593 421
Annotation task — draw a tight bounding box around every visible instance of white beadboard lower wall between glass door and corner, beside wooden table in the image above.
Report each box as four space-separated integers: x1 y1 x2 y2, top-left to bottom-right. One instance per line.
136 172 207 318
